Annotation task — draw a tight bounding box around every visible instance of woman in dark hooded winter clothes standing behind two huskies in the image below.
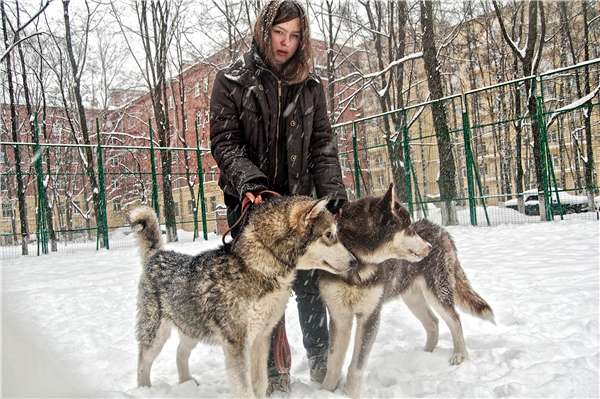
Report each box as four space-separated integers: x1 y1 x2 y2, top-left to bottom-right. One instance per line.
210 0 346 391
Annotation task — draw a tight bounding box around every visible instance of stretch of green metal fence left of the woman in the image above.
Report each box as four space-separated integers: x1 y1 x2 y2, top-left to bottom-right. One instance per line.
0 117 217 259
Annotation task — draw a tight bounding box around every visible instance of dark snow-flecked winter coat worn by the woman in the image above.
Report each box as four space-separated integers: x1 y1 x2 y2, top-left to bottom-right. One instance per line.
210 49 346 207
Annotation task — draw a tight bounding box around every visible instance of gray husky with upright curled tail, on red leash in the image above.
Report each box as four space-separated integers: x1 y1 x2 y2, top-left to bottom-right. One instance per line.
130 197 356 398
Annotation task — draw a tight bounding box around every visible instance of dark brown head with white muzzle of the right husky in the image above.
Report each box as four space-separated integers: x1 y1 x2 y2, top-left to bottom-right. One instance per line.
339 184 431 263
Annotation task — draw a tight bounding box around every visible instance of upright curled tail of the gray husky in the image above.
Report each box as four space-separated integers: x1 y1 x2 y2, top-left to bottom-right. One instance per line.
129 206 163 263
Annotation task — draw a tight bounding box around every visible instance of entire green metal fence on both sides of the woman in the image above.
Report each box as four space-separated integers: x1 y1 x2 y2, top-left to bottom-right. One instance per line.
0 59 600 259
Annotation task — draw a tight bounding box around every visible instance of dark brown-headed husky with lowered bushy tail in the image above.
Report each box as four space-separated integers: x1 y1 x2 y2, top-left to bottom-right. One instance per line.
320 185 494 397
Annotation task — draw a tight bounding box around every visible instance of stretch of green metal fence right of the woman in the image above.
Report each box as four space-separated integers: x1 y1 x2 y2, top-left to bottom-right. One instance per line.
334 59 600 226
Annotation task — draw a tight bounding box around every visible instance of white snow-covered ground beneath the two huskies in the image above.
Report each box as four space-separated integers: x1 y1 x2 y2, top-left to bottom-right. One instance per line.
2 220 600 398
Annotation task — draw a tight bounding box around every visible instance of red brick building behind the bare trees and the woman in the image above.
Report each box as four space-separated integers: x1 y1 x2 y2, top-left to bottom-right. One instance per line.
0 40 360 241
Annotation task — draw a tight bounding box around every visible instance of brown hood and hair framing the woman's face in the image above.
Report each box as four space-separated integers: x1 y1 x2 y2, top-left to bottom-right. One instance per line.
254 0 313 83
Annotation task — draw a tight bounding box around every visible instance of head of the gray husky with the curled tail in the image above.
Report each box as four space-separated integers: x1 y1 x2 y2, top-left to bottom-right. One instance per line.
243 196 356 274
